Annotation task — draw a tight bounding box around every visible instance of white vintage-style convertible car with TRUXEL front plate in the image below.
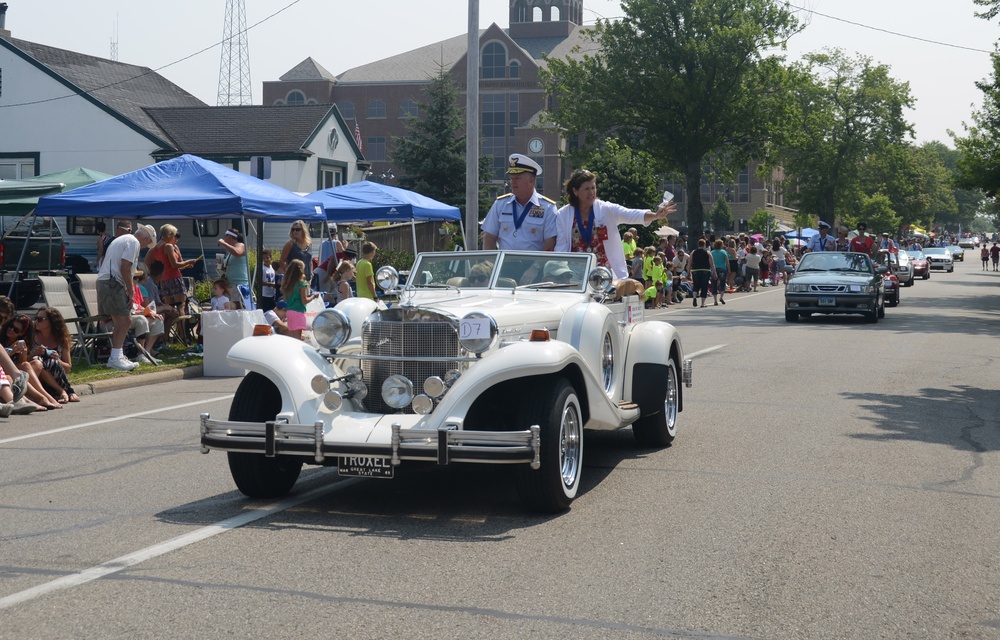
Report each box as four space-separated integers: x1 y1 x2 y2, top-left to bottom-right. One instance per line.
201 251 691 513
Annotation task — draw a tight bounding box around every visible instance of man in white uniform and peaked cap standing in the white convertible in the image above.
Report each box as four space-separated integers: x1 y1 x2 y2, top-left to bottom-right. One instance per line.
483 153 557 251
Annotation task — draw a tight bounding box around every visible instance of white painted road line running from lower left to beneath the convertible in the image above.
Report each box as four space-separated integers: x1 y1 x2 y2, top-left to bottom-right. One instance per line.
0 479 360 609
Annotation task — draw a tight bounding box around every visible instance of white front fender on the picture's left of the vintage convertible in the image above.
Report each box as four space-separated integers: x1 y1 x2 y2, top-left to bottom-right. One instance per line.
227 334 335 422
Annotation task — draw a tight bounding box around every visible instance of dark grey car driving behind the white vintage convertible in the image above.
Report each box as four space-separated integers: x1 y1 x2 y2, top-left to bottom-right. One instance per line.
785 251 887 322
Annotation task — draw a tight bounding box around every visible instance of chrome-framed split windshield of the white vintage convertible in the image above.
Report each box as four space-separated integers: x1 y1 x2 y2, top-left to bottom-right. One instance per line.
407 251 591 292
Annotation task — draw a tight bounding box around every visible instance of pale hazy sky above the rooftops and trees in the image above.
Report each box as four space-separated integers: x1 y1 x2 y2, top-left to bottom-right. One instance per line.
5 0 1000 145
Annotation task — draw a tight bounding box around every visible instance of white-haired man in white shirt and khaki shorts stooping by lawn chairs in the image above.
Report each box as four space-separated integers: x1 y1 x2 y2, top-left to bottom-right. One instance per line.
97 224 156 371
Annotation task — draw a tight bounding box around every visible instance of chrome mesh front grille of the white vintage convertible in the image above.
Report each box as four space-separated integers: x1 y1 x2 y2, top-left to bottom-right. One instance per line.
361 315 459 413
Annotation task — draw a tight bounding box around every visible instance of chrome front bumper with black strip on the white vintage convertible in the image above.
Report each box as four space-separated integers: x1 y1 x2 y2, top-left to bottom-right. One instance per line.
201 413 541 469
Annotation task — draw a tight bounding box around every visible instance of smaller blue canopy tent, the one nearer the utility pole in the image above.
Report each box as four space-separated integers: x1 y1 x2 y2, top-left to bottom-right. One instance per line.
306 180 465 253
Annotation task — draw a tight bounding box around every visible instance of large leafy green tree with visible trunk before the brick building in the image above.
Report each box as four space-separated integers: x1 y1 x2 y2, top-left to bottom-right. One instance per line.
541 0 798 236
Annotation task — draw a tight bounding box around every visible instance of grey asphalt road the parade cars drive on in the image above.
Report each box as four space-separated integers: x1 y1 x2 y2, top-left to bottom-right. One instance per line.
0 261 1000 639
